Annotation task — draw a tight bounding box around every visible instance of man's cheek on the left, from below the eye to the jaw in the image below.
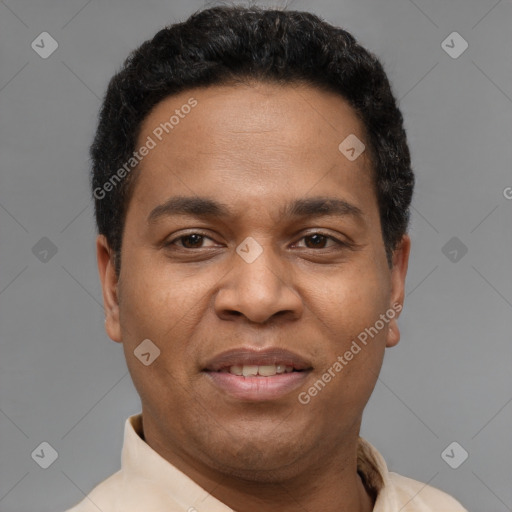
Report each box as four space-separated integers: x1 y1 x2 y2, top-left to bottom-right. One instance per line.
116 264 198 421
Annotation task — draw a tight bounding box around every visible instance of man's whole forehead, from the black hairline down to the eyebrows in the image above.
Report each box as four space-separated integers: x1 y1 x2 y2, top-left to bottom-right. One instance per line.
128 82 375 221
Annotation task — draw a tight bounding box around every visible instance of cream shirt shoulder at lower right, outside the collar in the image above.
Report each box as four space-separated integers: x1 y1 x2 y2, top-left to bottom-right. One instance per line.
388 472 467 512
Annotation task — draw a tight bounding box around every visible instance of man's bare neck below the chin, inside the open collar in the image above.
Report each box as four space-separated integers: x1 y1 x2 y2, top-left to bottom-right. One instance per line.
145 418 374 512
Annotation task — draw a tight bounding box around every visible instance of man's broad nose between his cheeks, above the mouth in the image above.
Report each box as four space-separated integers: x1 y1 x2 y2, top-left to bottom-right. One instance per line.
215 246 304 324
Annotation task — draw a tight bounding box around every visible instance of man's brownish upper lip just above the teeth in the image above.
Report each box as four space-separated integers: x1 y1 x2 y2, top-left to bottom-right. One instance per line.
204 347 312 372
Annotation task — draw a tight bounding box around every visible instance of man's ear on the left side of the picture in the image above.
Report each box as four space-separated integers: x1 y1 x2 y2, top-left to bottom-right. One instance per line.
96 235 121 342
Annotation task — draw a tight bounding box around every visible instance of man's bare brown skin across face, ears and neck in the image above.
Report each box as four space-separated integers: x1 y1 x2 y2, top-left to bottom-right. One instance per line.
97 83 410 512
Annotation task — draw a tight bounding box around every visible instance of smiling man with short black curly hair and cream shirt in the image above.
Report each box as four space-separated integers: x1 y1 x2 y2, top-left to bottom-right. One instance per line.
67 7 464 512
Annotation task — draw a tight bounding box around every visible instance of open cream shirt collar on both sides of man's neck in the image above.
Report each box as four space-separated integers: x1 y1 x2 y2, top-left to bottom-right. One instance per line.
121 414 398 512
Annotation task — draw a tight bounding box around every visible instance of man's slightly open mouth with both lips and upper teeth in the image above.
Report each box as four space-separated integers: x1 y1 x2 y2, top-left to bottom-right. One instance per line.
202 348 313 401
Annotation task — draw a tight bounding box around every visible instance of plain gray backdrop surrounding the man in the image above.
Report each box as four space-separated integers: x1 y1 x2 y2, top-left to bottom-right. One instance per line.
0 0 512 512
